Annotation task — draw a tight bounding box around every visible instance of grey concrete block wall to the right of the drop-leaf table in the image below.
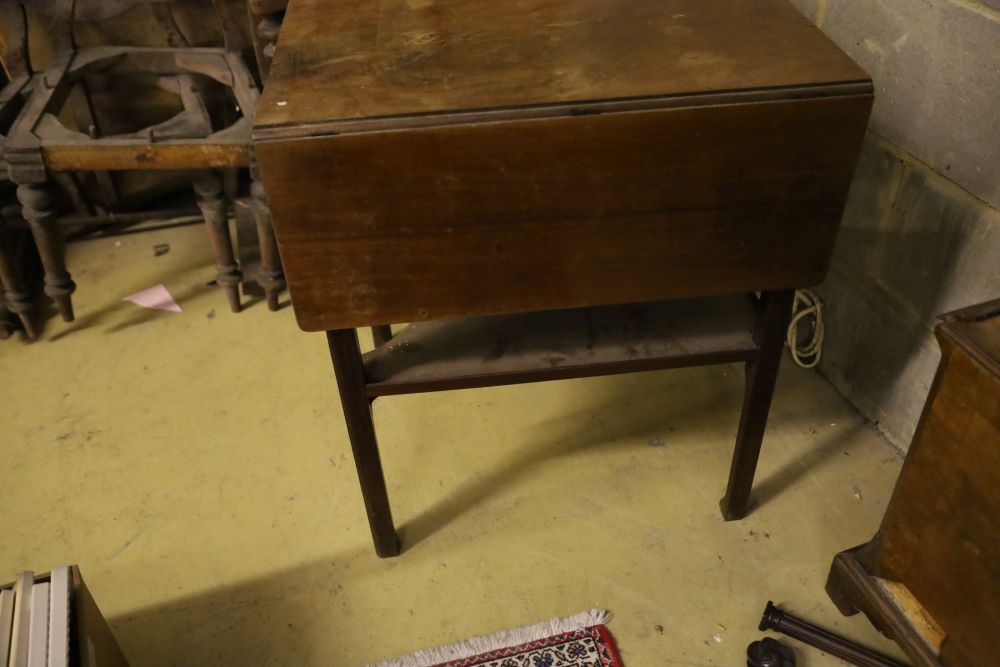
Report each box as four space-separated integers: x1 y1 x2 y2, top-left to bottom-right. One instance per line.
791 0 1000 448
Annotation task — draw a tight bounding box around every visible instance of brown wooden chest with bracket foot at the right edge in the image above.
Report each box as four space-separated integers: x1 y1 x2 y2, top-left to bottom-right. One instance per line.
828 300 1000 667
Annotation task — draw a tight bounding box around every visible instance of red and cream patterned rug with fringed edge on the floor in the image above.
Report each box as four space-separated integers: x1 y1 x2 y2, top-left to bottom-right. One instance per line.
367 609 622 667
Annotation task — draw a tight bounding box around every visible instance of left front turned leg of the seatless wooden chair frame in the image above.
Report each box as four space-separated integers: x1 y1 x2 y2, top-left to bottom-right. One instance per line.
17 183 76 322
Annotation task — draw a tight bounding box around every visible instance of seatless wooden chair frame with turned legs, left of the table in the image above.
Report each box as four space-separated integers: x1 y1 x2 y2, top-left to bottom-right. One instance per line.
0 0 284 321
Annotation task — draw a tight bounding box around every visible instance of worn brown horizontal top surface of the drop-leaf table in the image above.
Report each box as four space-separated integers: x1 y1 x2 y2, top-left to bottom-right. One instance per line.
256 0 868 138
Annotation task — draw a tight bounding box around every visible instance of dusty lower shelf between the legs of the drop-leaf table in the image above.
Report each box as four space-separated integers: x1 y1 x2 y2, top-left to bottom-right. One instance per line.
364 295 758 396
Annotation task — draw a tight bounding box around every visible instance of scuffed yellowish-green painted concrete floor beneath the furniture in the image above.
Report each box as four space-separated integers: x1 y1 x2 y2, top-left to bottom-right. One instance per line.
0 227 901 667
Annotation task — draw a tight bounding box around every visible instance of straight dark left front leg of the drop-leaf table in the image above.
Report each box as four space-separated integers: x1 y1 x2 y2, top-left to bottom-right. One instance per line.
326 329 399 558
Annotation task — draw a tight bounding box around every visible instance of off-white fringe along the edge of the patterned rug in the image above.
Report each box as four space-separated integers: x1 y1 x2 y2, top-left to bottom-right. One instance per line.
365 609 611 667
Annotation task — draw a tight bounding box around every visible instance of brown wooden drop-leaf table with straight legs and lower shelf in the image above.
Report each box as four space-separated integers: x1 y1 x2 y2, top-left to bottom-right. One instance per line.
255 0 872 556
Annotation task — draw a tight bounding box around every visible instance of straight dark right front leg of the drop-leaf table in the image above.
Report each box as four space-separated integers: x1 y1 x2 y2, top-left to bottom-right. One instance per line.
719 290 795 521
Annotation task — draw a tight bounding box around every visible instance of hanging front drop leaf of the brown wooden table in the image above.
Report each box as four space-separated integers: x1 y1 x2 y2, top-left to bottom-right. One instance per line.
256 95 871 331
